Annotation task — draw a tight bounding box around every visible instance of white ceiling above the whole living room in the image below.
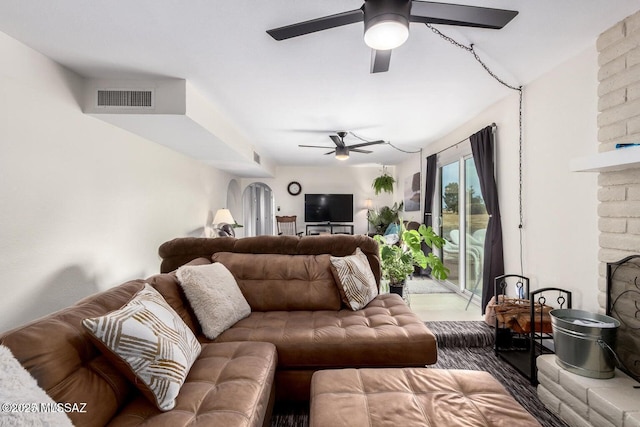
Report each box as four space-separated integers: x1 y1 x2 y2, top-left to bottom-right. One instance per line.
0 0 640 171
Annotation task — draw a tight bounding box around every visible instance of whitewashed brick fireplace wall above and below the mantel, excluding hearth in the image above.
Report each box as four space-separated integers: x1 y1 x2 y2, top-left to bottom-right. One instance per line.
597 12 640 311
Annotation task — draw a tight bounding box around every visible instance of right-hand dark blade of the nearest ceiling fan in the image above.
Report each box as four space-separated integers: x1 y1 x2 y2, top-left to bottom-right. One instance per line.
409 0 518 30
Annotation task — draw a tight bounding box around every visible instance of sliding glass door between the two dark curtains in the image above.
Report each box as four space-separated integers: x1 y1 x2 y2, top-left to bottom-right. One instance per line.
435 142 489 295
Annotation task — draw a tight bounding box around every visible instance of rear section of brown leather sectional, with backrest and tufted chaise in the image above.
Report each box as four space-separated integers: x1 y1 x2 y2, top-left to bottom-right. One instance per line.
159 235 437 400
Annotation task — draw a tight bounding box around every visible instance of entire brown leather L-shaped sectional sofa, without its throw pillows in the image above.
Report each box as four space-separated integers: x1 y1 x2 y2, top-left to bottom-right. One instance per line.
0 235 437 426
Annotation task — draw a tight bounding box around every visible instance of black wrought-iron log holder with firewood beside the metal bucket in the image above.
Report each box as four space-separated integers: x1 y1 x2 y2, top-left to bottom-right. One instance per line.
494 274 571 385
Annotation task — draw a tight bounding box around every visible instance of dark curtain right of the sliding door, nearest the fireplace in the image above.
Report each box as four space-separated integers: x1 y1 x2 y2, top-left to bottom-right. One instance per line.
469 126 504 314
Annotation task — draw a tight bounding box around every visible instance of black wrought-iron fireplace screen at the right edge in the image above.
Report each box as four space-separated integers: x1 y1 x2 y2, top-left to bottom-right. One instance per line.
606 255 640 382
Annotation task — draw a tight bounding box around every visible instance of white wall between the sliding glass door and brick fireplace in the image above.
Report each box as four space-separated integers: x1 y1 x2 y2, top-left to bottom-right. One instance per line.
398 47 598 311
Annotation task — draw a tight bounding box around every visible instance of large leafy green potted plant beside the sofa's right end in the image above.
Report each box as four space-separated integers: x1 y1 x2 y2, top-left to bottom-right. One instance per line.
374 224 449 296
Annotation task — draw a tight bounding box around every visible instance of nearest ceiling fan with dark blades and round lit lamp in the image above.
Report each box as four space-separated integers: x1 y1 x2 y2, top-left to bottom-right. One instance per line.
267 0 518 73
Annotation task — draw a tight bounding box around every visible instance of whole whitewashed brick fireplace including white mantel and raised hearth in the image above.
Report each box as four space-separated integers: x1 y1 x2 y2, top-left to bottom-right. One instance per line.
537 11 640 427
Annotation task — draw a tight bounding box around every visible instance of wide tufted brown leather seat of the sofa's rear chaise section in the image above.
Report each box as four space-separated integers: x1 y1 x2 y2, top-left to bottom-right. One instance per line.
216 294 437 370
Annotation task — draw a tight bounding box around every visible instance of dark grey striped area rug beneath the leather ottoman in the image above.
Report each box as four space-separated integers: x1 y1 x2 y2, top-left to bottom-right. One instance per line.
271 322 567 427
